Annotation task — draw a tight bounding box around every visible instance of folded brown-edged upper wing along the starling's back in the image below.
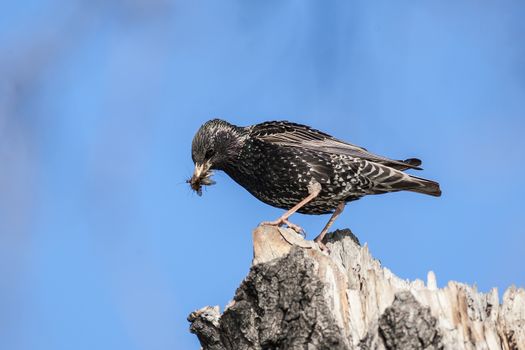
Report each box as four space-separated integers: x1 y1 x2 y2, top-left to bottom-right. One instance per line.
251 121 421 170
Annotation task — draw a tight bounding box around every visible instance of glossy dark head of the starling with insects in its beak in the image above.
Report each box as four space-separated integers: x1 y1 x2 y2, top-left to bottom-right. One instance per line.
187 119 242 196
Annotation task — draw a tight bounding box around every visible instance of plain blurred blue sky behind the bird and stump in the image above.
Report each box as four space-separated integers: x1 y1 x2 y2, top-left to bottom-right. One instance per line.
0 0 525 350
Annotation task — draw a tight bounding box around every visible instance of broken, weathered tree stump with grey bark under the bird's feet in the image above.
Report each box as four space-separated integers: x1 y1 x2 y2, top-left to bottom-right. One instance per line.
188 226 525 350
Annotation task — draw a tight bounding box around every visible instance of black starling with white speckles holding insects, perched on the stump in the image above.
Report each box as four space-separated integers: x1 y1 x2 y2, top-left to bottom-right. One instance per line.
187 118 441 250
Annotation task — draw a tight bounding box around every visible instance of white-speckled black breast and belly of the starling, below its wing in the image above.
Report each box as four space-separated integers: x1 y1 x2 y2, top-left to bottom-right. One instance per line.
224 142 360 214
